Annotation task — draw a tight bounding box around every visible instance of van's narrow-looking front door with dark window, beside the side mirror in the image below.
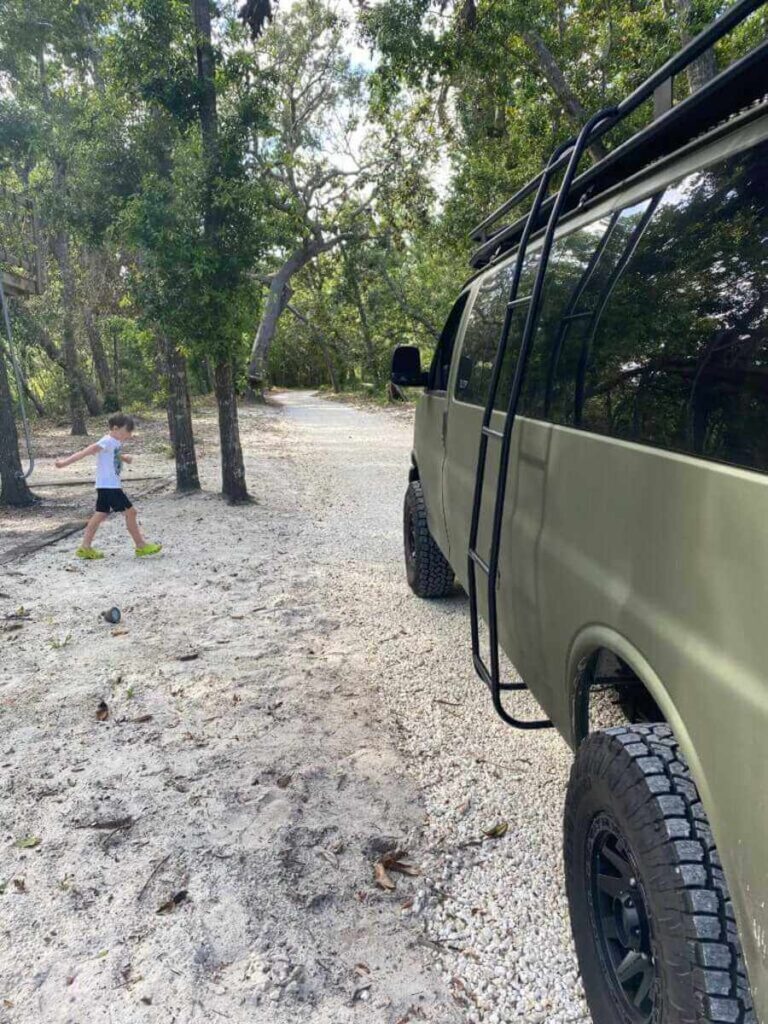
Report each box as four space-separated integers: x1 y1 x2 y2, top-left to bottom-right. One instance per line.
414 292 469 557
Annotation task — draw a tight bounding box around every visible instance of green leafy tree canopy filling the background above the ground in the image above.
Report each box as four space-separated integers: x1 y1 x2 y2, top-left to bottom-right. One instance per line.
0 0 766 500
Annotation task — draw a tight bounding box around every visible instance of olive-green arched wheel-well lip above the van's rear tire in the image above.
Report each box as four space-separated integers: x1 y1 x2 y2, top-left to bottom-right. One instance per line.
566 625 712 808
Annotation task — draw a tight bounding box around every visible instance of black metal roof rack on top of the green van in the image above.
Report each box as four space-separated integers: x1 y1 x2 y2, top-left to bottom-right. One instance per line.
470 0 768 269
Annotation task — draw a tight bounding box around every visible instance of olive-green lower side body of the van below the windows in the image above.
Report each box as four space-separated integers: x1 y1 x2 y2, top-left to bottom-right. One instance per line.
445 415 768 1019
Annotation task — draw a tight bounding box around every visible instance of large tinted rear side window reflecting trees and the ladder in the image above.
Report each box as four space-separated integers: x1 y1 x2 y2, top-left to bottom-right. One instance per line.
518 130 768 470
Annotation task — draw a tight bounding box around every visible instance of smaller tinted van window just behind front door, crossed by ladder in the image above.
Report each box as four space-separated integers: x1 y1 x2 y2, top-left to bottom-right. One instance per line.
456 261 534 409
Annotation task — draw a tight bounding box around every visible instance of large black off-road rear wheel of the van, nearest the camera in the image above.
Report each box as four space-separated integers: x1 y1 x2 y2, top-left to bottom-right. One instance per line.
564 725 756 1024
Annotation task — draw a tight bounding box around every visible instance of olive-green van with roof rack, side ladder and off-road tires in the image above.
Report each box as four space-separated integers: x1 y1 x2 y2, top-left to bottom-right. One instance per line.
392 2 768 1024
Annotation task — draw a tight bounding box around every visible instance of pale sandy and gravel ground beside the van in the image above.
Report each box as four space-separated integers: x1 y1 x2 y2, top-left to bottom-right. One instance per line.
0 392 589 1024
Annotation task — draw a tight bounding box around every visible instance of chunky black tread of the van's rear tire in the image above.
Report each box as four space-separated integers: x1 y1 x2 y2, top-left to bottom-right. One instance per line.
565 724 757 1024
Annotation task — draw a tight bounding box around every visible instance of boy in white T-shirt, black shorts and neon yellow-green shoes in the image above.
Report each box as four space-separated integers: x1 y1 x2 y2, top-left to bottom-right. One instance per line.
55 413 163 558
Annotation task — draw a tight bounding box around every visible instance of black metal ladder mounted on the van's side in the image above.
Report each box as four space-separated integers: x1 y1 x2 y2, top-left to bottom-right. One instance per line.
467 106 618 729
